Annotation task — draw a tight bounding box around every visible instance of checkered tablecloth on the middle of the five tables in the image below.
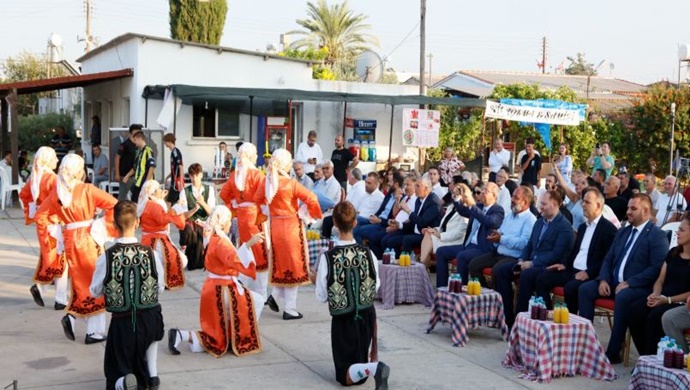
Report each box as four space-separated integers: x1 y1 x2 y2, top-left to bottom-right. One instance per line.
427 287 508 347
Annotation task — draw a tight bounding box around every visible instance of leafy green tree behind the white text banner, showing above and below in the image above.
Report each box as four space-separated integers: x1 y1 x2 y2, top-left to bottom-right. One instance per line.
490 83 592 169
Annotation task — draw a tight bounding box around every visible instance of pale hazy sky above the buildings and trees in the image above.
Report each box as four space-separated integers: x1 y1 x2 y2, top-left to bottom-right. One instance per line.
0 0 690 84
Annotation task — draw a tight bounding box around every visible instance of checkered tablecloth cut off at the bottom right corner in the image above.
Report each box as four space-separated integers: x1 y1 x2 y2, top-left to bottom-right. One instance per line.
628 355 690 390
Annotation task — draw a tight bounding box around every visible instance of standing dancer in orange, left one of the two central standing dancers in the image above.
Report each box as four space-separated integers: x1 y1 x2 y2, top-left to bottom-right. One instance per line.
220 142 279 312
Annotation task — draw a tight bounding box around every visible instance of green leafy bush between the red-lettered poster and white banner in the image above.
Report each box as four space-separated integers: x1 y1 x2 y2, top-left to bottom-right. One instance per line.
426 89 482 161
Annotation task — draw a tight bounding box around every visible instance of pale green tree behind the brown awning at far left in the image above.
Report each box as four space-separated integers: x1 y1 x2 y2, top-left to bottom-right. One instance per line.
2 51 67 115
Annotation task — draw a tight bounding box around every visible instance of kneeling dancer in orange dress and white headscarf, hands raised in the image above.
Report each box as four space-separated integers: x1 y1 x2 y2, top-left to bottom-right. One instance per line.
168 206 264 357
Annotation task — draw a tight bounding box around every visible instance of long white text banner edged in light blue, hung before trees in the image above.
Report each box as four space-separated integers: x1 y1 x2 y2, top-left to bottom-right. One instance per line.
485 100 580 126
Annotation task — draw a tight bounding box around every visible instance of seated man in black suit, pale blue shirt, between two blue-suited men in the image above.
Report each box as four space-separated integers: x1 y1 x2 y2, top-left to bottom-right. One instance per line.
537 187 617 313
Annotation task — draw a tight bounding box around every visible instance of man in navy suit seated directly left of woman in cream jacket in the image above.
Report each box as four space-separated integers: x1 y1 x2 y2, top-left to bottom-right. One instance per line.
381 178 443 257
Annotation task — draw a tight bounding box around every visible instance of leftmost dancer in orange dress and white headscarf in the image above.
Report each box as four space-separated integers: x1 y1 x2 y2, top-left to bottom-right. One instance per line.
19 146 67 310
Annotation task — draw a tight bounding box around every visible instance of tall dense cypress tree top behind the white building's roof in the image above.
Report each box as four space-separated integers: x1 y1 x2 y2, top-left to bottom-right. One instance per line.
169 0 228 45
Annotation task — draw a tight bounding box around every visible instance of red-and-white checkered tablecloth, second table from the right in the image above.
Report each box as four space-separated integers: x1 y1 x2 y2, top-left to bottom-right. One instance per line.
503 312 618 382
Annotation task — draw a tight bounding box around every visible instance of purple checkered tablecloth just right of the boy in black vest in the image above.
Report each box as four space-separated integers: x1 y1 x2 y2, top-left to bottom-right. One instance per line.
376 261 434 310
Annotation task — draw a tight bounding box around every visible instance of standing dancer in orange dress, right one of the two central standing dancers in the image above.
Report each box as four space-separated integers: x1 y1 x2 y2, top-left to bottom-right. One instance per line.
254 149 323 320
